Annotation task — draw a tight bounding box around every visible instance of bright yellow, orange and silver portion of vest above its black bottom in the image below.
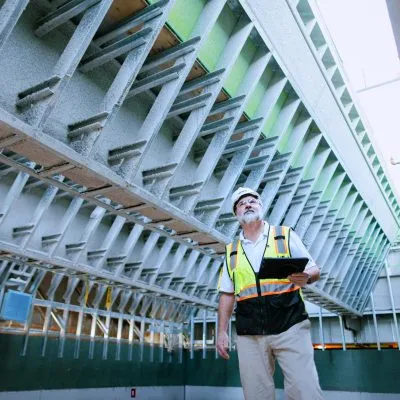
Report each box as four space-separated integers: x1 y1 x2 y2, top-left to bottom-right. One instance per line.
226 226 300 301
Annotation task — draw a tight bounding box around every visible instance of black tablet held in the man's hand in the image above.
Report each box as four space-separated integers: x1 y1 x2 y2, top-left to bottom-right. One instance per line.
257 257 309 279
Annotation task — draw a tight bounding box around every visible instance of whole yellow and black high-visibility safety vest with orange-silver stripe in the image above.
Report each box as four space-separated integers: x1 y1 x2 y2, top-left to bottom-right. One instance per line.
226 226 308 335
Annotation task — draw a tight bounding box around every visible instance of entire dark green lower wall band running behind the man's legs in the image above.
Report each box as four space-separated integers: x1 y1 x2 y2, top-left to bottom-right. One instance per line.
0 335 400 393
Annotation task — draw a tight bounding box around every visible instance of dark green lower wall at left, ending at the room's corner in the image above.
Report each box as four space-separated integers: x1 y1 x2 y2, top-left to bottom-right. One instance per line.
0 335 185 391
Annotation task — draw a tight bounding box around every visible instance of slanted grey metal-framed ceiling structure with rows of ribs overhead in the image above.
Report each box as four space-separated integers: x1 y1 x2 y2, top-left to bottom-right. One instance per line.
0 0 400 342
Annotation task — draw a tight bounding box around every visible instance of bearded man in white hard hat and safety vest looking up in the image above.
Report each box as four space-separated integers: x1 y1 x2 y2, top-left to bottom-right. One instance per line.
217 188 323 400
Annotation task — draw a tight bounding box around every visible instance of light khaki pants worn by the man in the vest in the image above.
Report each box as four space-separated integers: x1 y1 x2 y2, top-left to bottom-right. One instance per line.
237 319 323 400
